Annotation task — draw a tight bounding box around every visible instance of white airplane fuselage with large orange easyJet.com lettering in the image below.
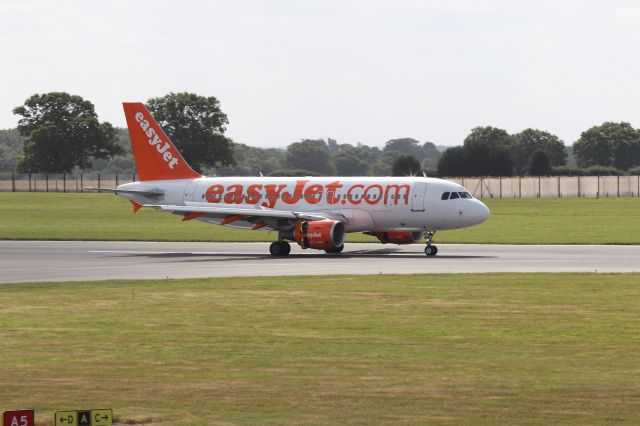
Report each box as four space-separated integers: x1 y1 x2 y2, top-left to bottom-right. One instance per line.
118 177 489 232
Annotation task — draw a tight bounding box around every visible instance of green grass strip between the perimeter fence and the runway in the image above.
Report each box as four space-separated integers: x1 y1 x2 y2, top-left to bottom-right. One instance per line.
0 193 640 244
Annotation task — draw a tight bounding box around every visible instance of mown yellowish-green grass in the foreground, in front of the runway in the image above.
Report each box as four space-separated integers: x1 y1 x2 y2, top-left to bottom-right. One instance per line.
0 274 640 425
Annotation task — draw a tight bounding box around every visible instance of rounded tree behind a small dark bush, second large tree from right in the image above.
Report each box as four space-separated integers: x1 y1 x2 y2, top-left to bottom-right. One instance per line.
513 129 567 175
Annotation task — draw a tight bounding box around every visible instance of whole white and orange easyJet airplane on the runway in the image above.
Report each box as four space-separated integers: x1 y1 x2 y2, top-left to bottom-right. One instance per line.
103 103 489 256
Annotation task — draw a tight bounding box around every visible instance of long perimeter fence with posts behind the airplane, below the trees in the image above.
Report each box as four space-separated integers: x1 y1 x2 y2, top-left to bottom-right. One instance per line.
0 173 640 198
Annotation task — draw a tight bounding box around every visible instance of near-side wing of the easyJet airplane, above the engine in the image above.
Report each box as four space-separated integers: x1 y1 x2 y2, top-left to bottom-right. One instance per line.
143 204 347 225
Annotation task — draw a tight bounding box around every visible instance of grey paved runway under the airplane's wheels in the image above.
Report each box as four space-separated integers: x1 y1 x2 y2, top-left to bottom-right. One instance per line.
0 241 640 283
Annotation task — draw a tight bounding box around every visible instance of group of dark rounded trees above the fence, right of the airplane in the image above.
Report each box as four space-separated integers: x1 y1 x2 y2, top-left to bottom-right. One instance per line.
438 122 640 176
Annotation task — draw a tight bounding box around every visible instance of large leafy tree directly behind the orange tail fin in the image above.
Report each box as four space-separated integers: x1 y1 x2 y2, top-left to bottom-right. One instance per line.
147 92 234 172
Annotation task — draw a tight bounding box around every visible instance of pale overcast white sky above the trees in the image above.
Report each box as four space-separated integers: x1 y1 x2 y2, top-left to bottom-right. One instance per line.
0 0 640 147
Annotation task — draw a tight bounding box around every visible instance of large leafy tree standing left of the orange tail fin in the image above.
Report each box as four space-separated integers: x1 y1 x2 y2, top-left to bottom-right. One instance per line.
13 92 123 173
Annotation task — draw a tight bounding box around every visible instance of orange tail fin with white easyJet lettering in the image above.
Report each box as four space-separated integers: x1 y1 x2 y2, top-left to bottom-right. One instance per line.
122 102 201 180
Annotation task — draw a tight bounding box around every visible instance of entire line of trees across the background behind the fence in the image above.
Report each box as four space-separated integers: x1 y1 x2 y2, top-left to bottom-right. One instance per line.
0 92 640 176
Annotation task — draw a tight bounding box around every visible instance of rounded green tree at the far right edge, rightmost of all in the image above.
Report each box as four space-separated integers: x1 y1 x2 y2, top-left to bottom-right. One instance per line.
573 121 640 170
